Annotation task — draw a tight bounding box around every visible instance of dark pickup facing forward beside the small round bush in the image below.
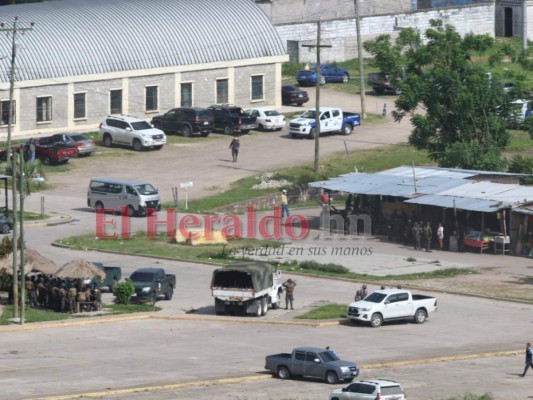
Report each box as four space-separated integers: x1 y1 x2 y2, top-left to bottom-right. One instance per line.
129 268 176 305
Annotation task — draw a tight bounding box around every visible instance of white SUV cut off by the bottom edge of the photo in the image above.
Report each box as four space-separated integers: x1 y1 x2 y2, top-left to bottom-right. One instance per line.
329 379 407 400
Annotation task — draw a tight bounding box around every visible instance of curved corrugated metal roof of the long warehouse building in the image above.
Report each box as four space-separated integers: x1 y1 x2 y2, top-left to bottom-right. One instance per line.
0 0 286 82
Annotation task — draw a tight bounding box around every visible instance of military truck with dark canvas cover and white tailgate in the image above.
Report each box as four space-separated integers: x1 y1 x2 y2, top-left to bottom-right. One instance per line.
211 262 283 317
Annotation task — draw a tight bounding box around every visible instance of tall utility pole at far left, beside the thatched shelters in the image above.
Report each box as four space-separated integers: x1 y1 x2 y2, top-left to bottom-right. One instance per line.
0 17 34 323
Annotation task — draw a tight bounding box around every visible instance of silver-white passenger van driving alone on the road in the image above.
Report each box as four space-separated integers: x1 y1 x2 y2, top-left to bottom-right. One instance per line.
87 178 161 217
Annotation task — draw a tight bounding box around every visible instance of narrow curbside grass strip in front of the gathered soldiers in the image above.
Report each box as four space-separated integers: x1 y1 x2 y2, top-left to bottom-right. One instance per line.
0 304 161 325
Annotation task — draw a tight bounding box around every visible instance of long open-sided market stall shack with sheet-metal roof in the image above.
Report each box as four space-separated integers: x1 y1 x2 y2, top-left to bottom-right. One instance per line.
310 166 533 254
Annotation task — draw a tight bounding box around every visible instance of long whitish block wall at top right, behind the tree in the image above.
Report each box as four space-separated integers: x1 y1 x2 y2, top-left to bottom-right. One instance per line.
276 4 496 62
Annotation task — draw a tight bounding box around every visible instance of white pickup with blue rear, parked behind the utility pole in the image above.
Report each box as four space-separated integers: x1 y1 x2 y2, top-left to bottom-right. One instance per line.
289 107 361 139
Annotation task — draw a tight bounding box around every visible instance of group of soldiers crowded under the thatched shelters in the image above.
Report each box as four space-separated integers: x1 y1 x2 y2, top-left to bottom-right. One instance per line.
9 275 101 313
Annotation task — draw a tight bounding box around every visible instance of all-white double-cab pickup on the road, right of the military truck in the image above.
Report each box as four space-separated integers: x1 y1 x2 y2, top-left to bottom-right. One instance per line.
348 289 437 328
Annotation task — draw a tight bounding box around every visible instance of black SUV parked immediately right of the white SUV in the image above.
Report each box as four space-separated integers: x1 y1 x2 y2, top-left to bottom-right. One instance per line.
152 107 215 137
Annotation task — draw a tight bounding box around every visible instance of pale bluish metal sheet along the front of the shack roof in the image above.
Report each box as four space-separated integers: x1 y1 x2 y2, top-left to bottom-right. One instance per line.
404 194 509 212
